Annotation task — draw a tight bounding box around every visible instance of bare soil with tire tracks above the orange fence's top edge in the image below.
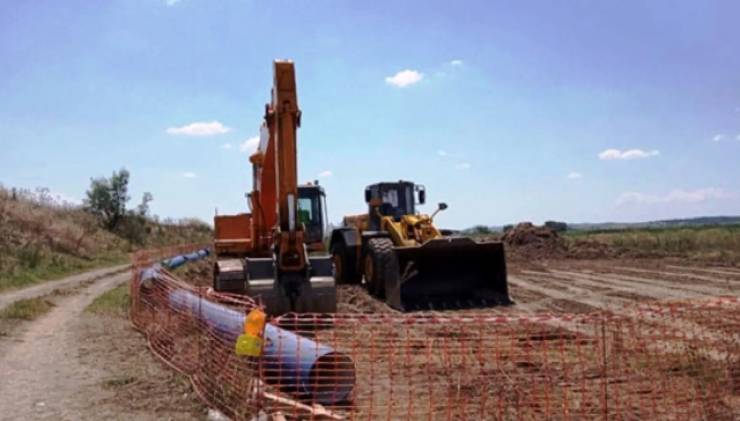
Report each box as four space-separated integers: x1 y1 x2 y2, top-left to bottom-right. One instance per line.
175 258 740 314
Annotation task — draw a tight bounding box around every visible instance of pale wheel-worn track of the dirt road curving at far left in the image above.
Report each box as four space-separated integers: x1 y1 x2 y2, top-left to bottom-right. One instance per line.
0 273 131 420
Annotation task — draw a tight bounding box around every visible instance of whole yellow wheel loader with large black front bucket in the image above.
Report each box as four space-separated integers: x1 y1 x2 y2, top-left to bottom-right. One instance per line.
329 180 512 311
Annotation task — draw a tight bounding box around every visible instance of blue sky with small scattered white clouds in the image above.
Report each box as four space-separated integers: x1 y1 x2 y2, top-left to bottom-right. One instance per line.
0 0 740 228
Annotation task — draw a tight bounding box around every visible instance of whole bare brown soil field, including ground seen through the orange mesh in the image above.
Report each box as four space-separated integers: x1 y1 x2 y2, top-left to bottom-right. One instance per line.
168 251 740 419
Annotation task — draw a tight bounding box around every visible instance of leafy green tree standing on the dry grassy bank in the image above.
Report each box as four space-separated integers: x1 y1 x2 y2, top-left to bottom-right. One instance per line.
85 168 130 230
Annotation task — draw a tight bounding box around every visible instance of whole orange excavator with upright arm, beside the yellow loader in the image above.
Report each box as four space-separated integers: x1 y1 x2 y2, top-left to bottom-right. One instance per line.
213 60 337 315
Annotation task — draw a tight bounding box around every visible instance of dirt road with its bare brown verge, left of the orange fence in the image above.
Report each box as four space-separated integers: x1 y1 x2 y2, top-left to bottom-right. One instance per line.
0 267 203 420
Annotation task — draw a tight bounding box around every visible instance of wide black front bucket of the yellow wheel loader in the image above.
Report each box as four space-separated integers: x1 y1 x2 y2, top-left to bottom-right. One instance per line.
385 237 513 311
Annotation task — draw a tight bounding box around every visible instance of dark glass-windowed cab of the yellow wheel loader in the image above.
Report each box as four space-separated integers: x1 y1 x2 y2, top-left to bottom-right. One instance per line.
365 180 426 230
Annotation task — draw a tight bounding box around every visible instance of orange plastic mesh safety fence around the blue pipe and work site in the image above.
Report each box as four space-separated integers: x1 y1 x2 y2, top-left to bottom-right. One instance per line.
131 248 740 420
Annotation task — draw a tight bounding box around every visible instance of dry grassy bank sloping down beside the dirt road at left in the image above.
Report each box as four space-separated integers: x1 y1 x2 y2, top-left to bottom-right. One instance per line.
0 186 212 290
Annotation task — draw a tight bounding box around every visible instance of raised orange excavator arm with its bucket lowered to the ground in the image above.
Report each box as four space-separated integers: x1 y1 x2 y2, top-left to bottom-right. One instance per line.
245 60 336 314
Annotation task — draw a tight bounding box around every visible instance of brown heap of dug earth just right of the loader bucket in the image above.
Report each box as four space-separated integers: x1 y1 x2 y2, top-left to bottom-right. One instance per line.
501 222 568 260
